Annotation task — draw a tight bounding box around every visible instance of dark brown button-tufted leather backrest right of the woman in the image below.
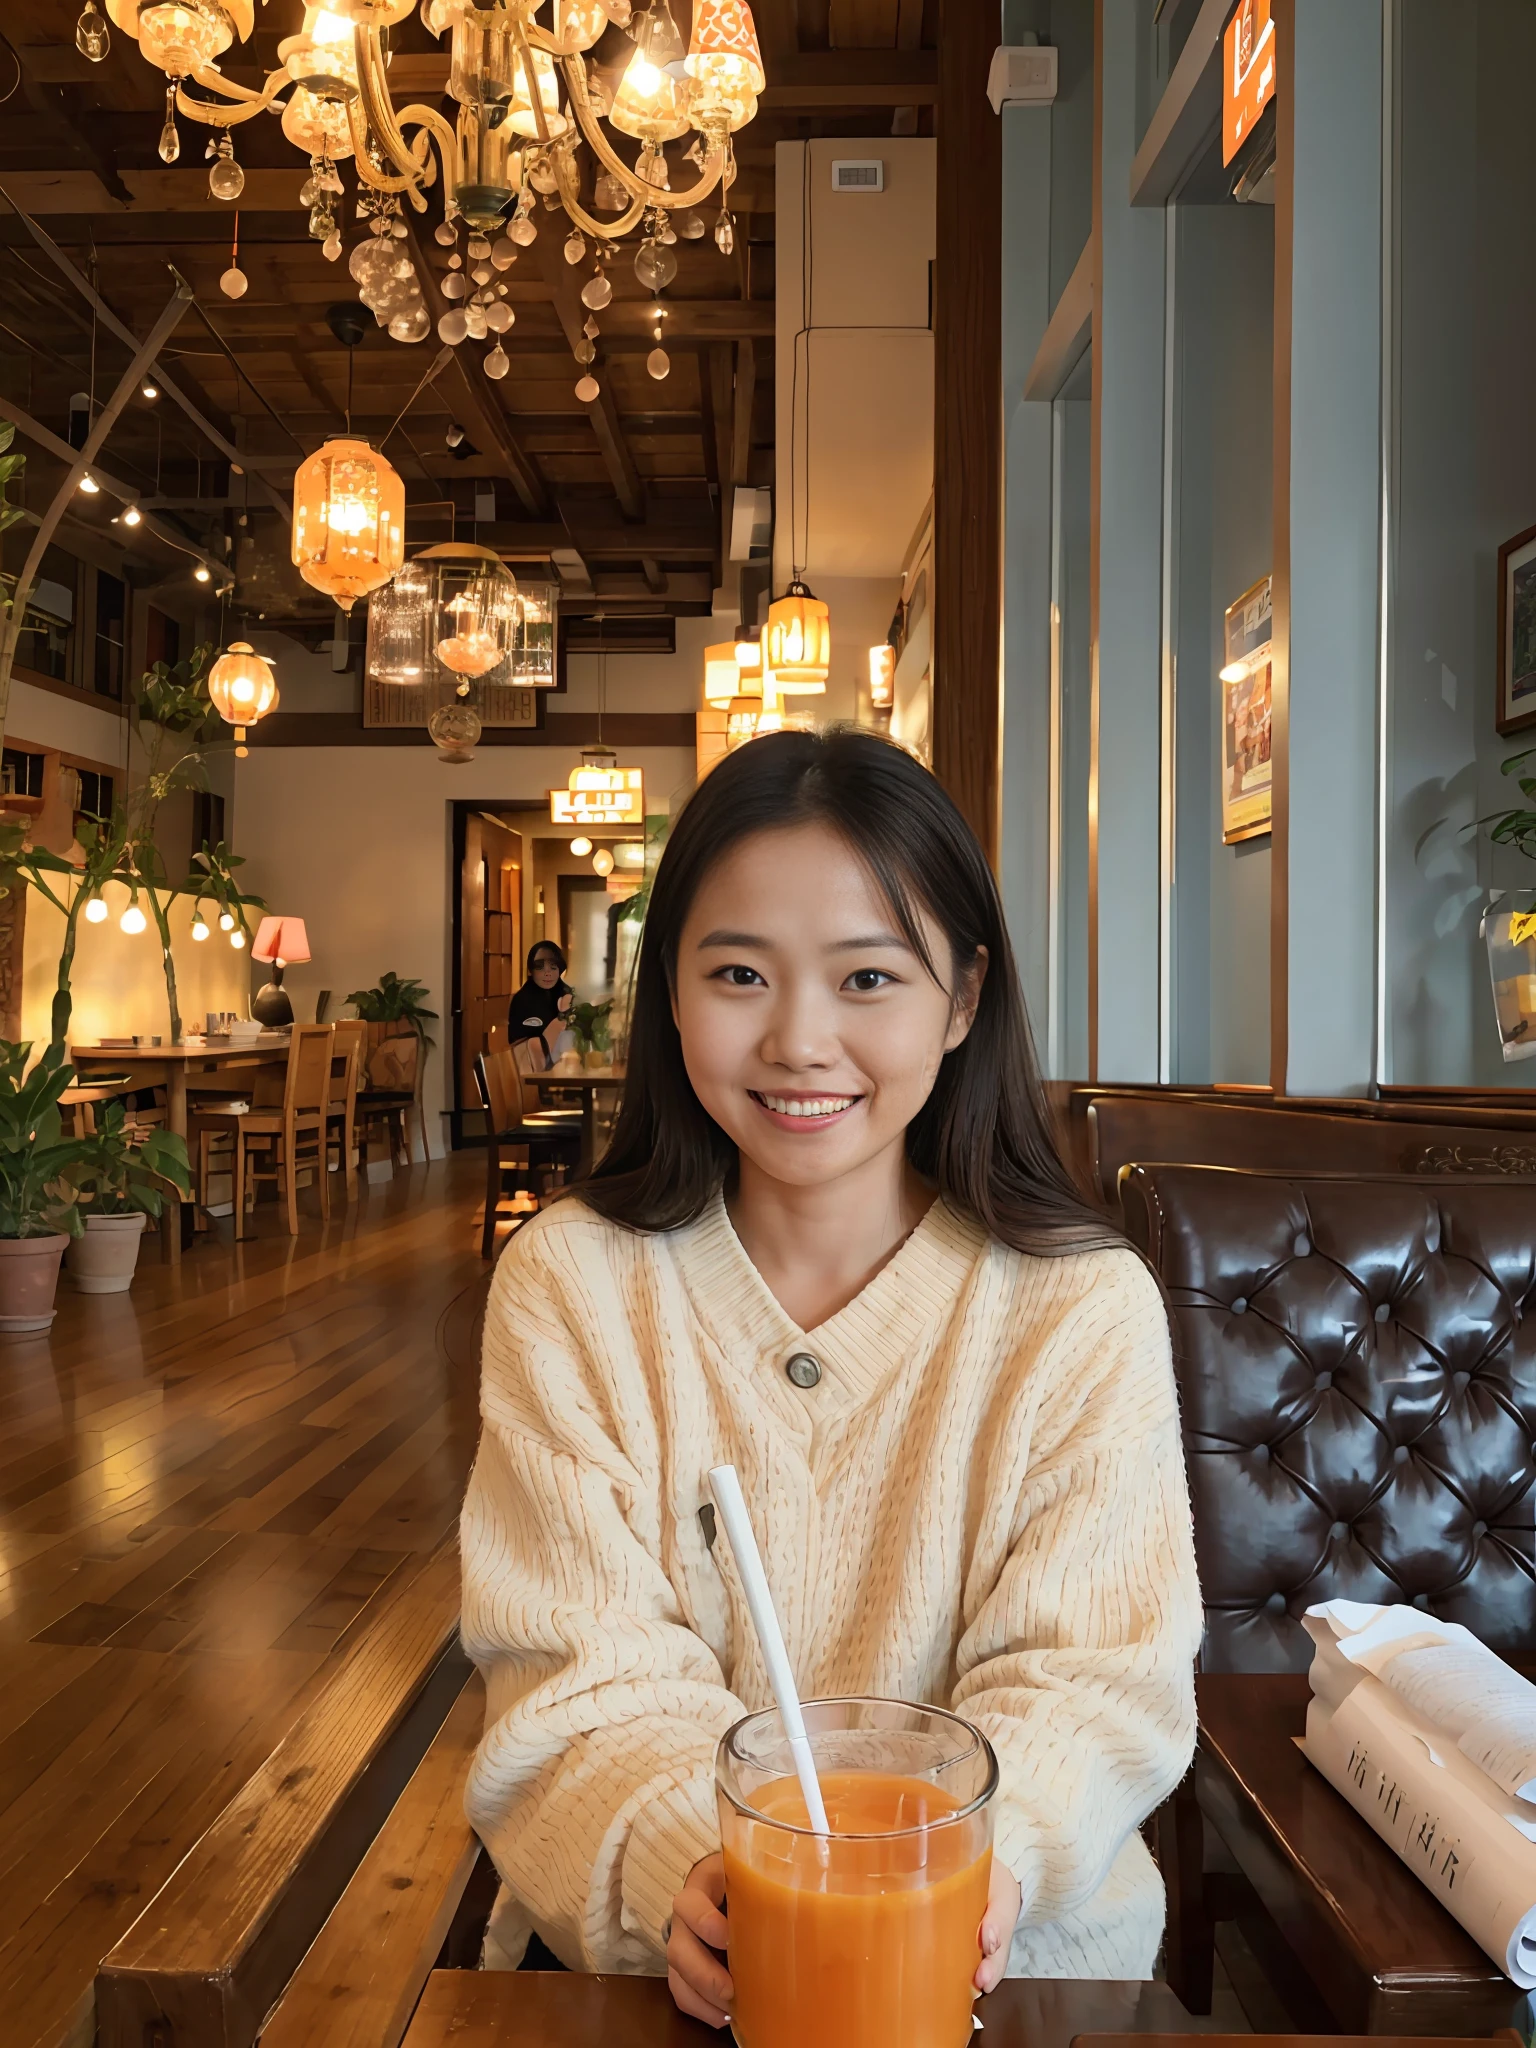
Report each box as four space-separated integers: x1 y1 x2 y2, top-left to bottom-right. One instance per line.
1120 1165 1536 1671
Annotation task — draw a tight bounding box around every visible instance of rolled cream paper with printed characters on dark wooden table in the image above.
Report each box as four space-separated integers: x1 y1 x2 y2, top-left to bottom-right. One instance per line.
1300 1599 1536 1991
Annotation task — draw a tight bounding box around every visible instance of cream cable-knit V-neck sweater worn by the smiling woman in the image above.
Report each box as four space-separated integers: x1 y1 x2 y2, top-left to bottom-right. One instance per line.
463 1200 1200 1978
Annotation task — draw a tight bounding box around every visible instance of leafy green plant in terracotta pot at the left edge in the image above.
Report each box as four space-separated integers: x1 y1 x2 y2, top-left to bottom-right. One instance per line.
0 1038 90 1331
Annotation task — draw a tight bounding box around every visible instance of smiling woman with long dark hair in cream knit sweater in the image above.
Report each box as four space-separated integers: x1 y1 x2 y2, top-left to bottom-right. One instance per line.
463 731 1200 2025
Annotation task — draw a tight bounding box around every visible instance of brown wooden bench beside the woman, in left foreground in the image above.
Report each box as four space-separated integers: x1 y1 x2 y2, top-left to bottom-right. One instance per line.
96 1544 483 2048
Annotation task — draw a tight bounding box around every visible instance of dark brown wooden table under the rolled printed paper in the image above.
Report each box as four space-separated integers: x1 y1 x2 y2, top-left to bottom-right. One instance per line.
1196 1673 1526 2048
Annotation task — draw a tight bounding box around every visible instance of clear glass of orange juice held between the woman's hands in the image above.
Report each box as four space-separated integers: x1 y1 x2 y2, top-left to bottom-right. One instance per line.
715 1700 997 2048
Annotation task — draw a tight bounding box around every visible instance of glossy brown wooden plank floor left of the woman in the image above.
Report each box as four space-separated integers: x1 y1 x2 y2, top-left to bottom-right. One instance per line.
0 1153 487 2048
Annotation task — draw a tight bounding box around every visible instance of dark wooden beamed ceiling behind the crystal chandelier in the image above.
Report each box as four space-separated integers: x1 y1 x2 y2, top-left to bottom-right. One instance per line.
0 0 938 625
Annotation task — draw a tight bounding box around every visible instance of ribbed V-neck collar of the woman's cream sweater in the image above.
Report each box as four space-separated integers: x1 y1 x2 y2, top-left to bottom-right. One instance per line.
668 1194 987 1401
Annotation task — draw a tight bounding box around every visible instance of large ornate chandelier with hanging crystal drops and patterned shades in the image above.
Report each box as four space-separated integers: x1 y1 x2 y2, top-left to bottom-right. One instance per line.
111 0 766 399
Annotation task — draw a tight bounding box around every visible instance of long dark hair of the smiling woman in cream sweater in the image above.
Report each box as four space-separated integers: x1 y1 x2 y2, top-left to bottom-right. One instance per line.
578 727 1124 1255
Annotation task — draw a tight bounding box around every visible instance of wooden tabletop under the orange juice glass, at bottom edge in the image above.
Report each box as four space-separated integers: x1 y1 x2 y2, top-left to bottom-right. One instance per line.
403 1970 1220 2048
